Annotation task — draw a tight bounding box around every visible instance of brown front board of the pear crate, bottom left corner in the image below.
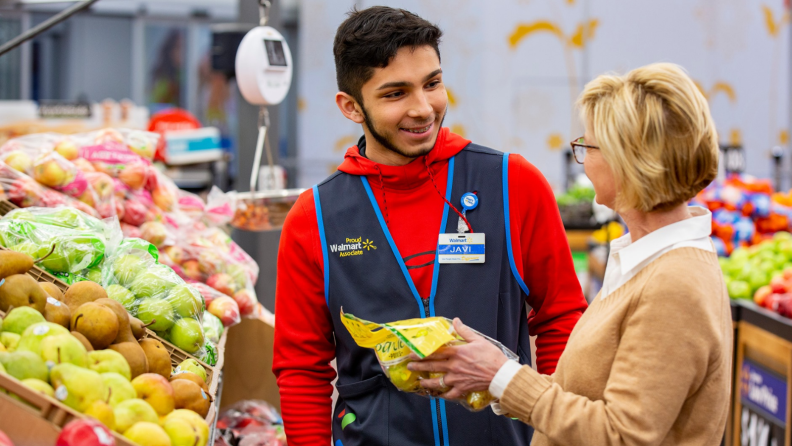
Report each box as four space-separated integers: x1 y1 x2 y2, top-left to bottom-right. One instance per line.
0 373 135 446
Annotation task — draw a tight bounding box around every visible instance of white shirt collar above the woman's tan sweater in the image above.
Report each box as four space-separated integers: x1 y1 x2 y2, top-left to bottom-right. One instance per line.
611 206 712 274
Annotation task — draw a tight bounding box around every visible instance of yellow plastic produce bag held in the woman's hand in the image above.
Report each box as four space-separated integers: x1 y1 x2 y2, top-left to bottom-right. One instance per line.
341 308 519 412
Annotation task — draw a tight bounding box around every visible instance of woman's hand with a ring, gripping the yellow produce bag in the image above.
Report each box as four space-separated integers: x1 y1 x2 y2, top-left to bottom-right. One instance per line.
407 318 508 400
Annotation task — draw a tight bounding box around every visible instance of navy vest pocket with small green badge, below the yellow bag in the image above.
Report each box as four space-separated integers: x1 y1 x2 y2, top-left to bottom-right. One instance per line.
333 375 390 446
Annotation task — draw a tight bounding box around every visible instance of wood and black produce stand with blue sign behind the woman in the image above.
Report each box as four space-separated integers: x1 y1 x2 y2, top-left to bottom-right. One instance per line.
726 300 792 446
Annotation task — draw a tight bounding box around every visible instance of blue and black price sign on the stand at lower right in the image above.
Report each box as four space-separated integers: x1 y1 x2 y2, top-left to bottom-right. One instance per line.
740 359 787 446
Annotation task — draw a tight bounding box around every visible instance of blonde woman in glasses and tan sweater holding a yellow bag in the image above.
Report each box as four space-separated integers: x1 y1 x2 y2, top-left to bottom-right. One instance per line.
410 64 732 445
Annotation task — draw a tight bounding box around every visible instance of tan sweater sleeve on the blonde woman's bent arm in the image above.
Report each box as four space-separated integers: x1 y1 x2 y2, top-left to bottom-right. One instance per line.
500 265 722 445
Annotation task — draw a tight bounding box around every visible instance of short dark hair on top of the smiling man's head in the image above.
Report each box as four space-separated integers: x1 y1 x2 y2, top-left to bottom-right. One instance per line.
333 6 443 104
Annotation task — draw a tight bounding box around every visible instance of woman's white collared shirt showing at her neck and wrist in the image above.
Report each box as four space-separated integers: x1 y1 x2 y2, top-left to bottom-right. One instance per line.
489 206 715 398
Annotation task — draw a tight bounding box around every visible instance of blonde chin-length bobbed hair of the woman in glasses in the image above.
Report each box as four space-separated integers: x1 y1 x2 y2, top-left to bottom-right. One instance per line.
578 63 719 212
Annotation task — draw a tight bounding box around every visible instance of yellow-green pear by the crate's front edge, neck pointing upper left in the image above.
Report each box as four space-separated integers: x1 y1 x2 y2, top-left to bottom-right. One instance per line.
50 363 105 412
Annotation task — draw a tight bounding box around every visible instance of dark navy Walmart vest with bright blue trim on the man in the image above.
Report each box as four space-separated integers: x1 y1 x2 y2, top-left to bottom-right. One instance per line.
313 144 533 446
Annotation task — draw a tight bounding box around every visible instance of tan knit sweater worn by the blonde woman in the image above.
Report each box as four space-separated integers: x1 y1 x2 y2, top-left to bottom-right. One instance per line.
500 248 732 446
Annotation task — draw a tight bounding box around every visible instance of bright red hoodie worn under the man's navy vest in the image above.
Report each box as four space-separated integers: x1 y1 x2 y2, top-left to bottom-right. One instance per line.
273 128 586 446
